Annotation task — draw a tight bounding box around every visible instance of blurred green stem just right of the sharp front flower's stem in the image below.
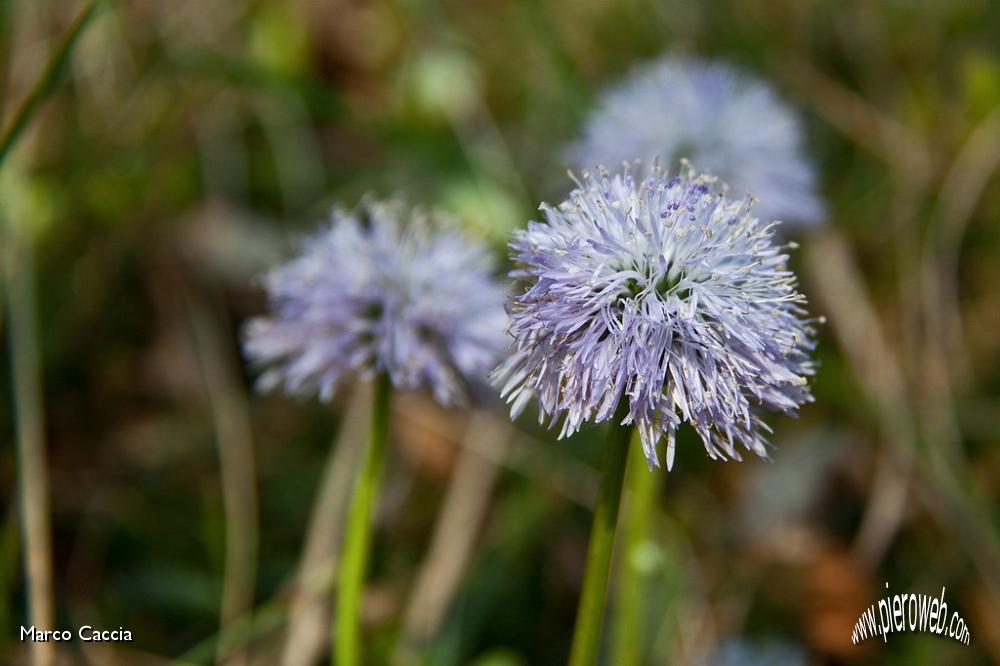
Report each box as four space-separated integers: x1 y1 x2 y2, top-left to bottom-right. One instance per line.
611 437 659 666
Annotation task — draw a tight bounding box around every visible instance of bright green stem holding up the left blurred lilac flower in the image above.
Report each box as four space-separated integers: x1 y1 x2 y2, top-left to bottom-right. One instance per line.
332 373 392 666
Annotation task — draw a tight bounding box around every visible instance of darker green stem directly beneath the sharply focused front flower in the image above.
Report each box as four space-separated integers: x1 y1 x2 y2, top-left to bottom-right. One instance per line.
569 399 632 666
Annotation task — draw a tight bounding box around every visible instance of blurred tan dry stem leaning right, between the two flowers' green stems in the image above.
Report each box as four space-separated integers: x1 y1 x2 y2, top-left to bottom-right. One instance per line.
393 412 511 664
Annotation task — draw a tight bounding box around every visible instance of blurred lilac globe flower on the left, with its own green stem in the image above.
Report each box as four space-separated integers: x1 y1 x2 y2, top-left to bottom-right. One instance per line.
245 201 507 404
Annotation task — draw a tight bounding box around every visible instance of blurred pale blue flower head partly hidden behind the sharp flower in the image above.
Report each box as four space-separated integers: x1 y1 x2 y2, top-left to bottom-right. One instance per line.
570 57 823 225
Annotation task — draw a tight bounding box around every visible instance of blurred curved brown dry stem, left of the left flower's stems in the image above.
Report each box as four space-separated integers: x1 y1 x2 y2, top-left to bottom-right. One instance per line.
188 296 258 664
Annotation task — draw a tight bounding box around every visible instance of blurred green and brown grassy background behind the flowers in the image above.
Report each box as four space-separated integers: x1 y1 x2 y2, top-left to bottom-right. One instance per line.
0 0 1000 666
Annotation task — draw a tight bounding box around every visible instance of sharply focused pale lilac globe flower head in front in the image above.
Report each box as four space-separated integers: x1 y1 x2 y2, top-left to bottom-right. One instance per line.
494 168 814 469
